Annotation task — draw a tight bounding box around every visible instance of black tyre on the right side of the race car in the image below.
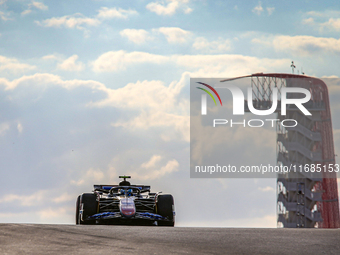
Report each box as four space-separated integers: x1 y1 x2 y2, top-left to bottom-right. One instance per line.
156 194 175 227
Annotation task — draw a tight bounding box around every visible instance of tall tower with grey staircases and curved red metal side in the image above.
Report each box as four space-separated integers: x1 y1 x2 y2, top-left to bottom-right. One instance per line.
223 73 340 228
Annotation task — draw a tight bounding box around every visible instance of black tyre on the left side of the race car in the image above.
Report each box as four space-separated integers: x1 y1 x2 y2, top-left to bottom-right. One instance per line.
79 193 98 224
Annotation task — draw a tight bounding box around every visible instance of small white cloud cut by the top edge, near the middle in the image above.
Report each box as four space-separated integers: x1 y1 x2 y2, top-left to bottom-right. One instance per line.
146 0 192 16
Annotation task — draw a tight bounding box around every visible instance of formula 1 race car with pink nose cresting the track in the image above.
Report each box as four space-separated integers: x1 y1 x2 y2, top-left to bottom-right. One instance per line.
76 176 175 227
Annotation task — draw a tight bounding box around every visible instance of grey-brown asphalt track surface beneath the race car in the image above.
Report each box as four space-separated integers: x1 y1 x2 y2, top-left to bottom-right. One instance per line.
0 224 340 255
